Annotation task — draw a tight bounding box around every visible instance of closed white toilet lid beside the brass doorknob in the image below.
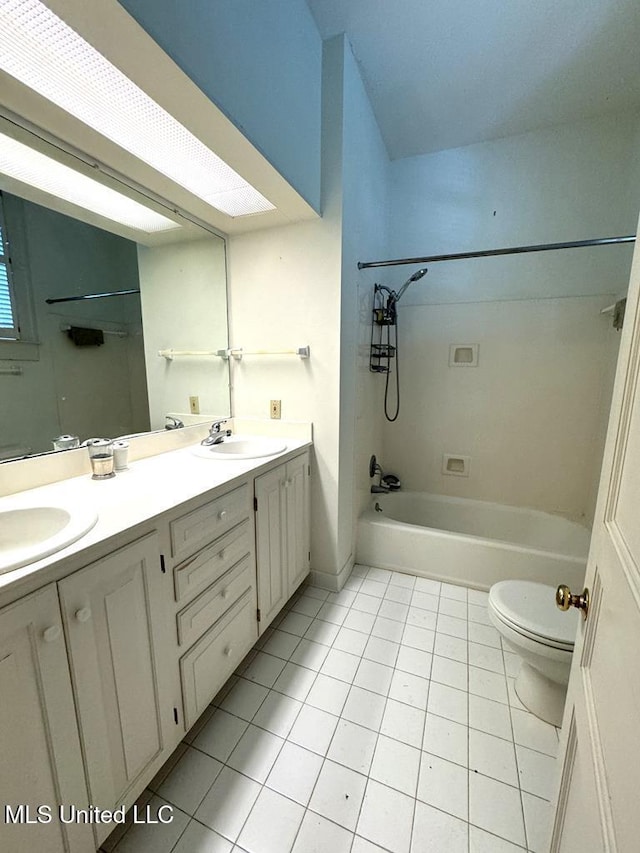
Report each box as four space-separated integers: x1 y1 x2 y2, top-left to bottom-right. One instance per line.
489 581 578 649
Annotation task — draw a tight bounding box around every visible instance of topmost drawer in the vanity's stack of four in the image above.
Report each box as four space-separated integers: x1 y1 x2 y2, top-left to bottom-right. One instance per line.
169 484 250 558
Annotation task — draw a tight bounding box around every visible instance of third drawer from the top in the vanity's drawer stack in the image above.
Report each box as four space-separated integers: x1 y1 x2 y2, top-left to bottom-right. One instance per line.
177 554 255 646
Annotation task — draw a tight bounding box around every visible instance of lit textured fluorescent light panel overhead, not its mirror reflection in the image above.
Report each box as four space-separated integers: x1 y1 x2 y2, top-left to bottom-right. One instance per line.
0 0 274 216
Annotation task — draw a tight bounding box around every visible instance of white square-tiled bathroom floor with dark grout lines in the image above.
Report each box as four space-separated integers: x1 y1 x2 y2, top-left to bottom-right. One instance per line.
105 566 558 853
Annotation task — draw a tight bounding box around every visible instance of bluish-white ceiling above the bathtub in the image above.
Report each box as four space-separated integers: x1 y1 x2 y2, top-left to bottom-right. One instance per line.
307 0 640 159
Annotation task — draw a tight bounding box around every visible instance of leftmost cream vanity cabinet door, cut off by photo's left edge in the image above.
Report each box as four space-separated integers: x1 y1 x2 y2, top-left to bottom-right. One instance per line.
0 584 94 853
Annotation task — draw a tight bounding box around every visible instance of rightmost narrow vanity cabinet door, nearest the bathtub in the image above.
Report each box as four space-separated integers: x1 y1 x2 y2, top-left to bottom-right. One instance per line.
284 454 309 596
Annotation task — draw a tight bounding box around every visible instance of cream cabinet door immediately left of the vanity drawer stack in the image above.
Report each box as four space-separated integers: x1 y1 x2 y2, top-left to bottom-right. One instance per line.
59 534 165 824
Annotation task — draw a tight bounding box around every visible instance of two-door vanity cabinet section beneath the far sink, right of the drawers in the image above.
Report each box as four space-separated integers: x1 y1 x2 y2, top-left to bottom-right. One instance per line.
254 452 310 633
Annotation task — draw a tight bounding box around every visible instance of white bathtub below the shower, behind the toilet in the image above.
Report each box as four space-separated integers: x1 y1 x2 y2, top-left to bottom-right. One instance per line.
356 492 591 589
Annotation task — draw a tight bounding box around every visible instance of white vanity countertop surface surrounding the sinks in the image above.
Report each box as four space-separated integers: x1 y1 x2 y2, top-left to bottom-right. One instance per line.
0 438 311 606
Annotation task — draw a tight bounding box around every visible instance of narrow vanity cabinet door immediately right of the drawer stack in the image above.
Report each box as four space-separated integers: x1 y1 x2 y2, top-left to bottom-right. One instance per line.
255 465 289 633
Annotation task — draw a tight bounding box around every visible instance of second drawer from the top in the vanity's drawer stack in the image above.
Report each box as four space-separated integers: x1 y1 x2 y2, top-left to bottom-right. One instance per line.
173 519 251 601
